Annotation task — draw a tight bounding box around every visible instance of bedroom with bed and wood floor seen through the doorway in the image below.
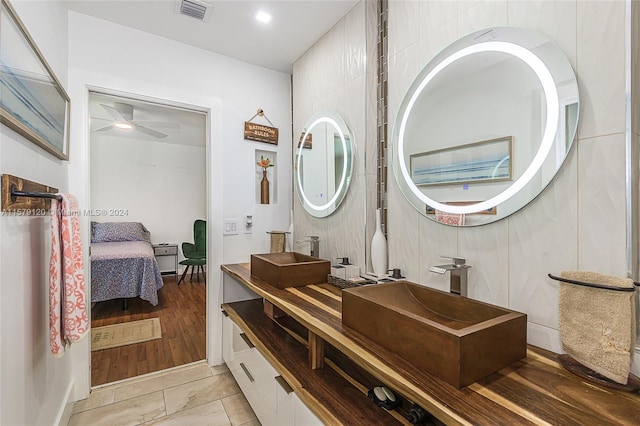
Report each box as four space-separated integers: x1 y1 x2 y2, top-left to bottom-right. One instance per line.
89 91 208 386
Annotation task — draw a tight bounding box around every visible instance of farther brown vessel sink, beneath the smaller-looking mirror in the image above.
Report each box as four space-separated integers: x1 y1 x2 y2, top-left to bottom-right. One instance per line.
251 252 331 288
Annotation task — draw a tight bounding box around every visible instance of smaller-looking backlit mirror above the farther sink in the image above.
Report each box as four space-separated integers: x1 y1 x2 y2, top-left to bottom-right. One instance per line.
293 112 353 217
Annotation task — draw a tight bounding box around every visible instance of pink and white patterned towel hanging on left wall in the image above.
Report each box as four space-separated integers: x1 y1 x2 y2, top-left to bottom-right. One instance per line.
49 194 90 358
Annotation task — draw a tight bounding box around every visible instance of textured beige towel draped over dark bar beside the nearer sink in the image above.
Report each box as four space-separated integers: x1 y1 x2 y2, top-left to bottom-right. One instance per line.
558 271 636 384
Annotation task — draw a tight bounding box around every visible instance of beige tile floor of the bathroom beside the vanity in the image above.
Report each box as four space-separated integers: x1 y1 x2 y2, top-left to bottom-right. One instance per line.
68 361 260 426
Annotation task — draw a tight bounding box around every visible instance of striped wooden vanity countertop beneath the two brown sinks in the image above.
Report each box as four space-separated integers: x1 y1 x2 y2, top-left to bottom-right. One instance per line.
222 263 640 425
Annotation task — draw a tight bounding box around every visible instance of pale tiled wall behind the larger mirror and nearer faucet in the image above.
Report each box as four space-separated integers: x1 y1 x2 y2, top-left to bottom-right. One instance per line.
388 1 627 362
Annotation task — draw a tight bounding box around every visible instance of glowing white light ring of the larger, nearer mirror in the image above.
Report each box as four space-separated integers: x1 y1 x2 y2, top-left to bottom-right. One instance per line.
397 41 560 214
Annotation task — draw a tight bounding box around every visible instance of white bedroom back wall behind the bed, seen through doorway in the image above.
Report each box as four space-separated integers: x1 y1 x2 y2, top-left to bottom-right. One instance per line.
91 135 207 253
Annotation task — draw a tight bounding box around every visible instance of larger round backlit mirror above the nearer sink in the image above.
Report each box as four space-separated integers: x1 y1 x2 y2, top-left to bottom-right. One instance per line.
390 27 579 226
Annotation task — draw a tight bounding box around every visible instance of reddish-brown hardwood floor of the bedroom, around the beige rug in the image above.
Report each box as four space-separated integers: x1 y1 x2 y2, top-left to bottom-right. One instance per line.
91 275 206 386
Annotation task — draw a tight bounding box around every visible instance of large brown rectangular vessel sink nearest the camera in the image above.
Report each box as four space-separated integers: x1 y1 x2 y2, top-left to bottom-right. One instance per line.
342 281 527 388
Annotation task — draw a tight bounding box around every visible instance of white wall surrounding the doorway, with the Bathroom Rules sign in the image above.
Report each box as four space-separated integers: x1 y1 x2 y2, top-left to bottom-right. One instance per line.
69 12 291 398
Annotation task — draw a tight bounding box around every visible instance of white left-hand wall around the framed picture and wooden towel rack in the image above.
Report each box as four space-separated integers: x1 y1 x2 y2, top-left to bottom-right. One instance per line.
0 0 78 425
